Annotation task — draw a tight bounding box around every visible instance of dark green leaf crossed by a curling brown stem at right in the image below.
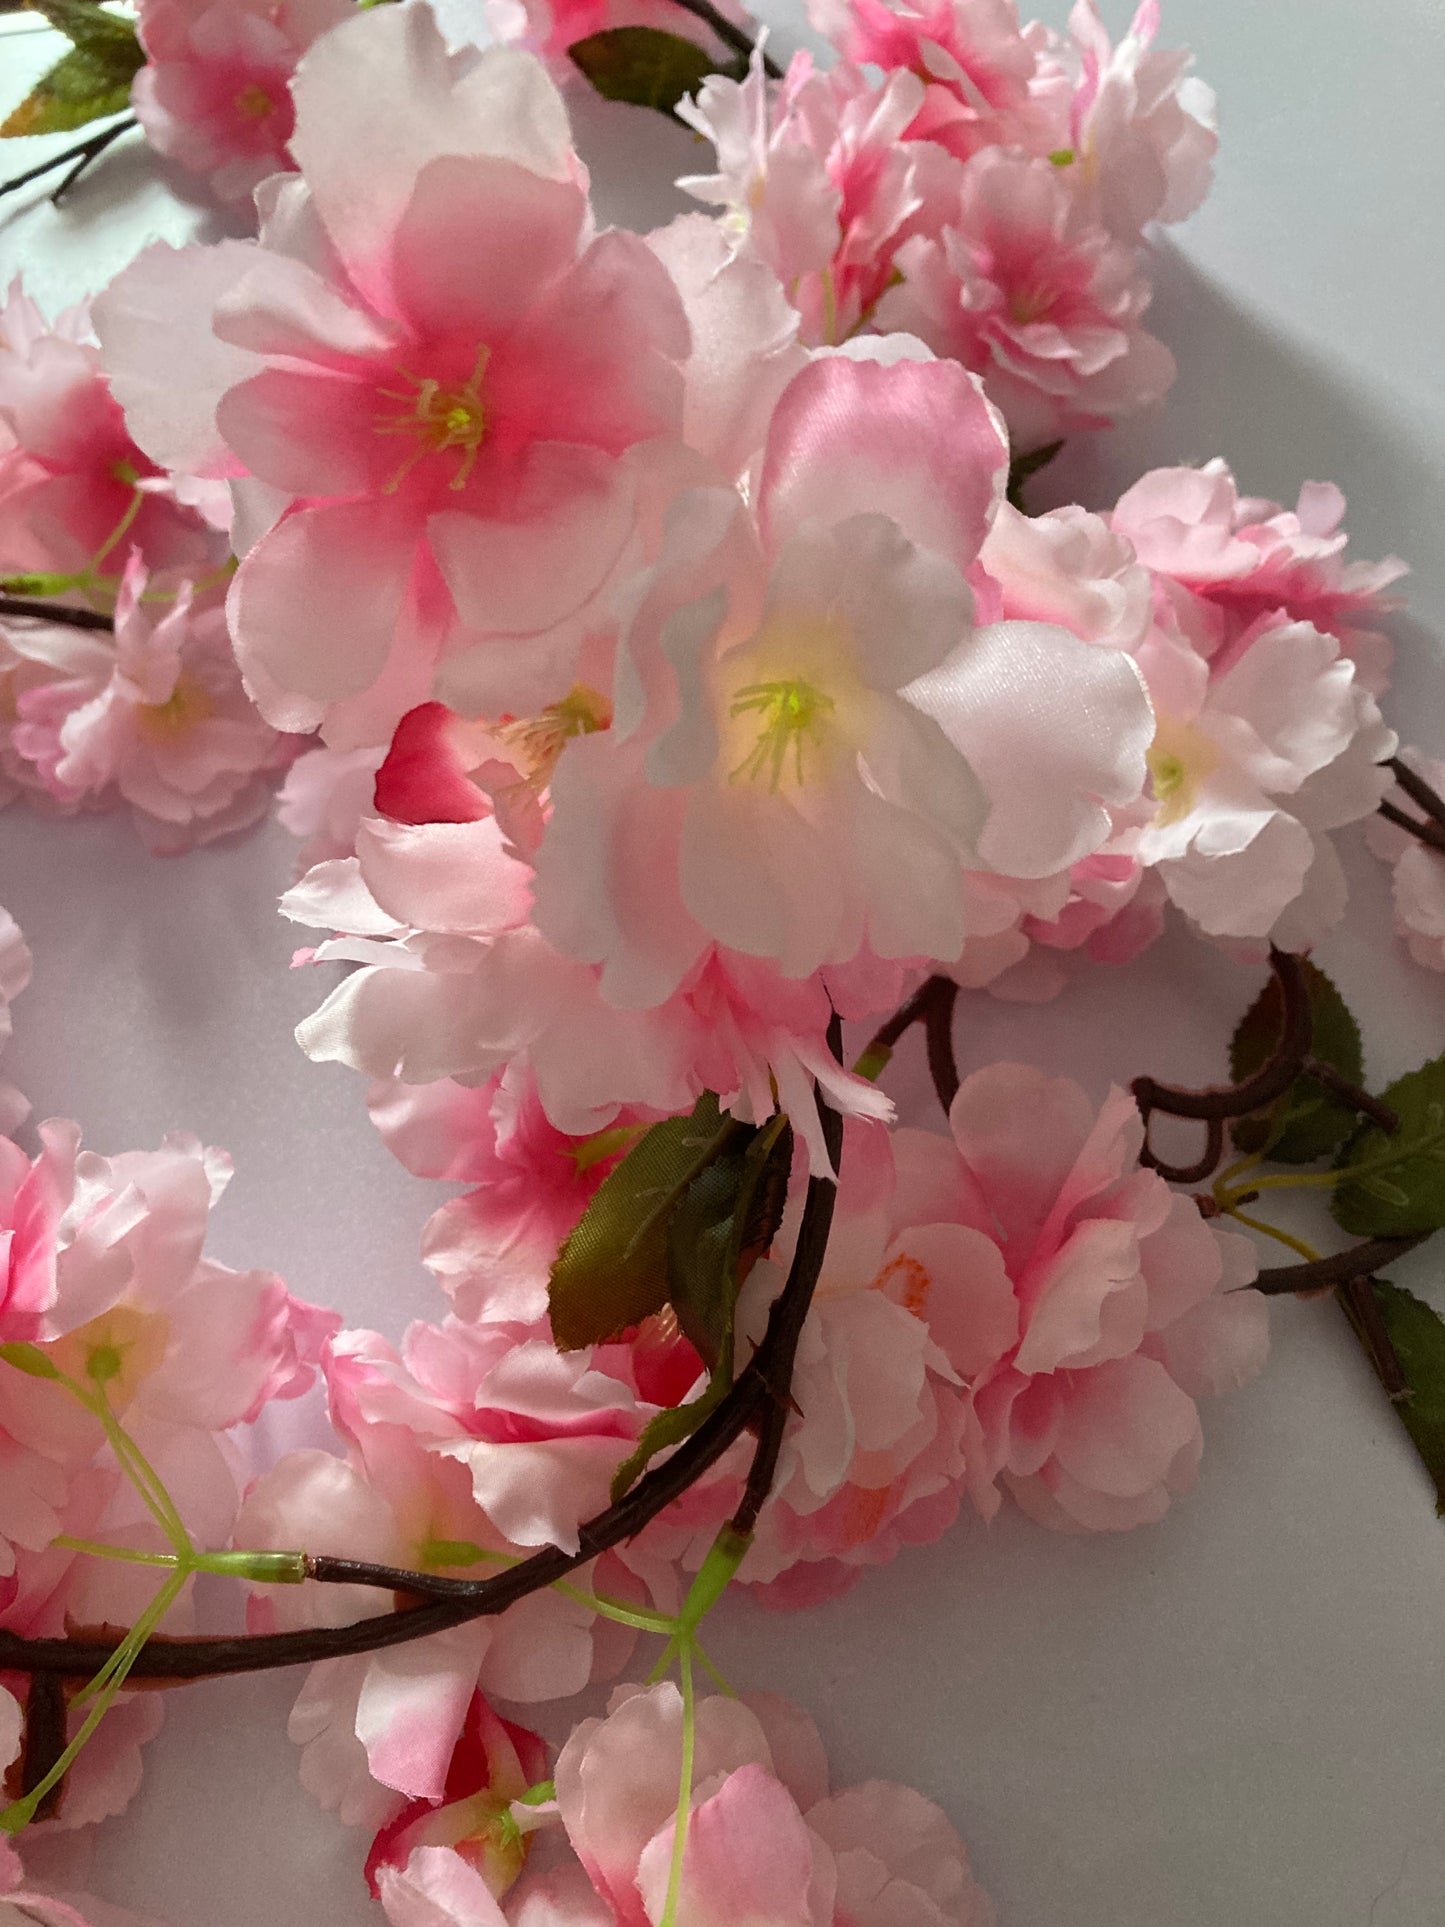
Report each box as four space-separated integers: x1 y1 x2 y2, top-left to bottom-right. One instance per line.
1229 962 1364 1164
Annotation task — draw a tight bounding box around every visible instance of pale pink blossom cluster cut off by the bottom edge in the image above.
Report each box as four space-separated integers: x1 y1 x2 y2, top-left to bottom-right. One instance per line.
370 1686 994 1927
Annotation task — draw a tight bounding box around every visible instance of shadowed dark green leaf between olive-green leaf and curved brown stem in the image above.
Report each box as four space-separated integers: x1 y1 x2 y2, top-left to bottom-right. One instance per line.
667 1123 792 1386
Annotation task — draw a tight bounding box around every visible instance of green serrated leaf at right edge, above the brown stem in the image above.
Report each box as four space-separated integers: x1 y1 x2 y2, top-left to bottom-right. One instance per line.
1331 1056 1445 1237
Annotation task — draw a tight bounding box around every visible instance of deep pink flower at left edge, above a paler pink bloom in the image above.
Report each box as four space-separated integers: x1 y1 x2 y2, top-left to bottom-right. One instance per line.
0 281 222 576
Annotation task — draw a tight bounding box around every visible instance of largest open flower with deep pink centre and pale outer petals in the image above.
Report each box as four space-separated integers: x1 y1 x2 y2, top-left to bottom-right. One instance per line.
100 6 688 748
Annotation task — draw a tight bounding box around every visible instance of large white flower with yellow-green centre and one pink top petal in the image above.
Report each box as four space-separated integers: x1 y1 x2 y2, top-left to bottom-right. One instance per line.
536 343 1143 1008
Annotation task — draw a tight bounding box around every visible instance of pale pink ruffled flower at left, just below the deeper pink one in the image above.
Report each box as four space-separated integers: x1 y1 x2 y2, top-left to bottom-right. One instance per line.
12 551 297 854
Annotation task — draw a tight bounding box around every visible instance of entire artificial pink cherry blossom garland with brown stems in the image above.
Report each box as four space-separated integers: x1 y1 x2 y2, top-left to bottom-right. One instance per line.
0 8 1439 1927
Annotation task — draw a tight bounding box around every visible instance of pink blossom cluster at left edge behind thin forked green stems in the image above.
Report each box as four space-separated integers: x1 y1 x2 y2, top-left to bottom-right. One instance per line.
0 1002 339 1826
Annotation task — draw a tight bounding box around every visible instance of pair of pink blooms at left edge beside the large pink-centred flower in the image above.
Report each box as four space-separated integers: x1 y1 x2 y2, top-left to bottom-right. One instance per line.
0 287 297 852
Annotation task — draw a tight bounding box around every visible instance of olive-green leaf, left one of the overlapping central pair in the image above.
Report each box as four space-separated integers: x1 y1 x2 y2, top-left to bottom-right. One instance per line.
547 1091 749 1351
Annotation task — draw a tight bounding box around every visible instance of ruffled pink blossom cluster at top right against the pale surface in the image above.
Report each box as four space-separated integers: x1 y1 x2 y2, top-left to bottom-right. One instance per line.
680 0 1216 451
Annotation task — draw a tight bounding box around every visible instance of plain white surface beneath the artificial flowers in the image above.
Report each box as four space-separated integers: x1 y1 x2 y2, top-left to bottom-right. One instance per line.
0 0 1445 1927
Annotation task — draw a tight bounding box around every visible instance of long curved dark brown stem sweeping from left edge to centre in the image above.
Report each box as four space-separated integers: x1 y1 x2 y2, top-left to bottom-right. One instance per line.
0 1079 842 1682
